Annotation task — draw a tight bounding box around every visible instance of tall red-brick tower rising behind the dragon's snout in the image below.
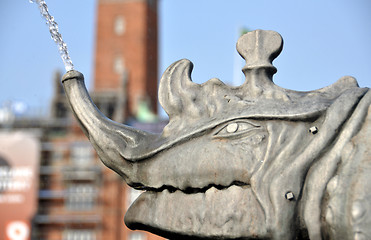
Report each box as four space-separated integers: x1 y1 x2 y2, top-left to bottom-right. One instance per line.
94 0 157 120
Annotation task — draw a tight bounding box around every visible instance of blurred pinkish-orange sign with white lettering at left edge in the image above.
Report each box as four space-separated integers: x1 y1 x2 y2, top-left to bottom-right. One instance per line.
0 133 40 240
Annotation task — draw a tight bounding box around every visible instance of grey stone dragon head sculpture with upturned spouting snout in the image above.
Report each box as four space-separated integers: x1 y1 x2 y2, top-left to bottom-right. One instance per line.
63 30 371 239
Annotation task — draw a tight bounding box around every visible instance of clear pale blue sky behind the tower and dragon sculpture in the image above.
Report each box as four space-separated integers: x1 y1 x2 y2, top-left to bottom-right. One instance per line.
0 0 371 116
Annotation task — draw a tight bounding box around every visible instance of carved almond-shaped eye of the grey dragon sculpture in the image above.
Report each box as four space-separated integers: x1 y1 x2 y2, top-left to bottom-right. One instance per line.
213 120 261 138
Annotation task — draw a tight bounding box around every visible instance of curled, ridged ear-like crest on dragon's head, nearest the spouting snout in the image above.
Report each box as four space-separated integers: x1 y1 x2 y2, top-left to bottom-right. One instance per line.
158 59 200 118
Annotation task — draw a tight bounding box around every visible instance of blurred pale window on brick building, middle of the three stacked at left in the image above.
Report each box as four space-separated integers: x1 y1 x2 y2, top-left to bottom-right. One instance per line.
65 184 97 211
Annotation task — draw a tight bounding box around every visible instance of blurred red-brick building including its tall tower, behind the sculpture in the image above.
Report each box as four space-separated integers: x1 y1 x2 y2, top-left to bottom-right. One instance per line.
0 0 166 240
